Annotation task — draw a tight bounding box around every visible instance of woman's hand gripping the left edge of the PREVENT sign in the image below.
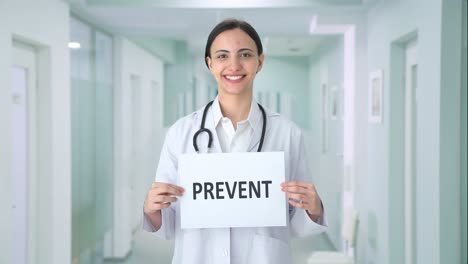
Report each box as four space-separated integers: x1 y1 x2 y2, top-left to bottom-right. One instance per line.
144 182 184 217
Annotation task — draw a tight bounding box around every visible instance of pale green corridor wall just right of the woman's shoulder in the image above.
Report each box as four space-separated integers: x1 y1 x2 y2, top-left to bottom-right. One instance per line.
307 37 344 250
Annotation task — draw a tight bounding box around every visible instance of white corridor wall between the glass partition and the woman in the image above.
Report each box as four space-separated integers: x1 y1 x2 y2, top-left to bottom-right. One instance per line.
111 37 164 258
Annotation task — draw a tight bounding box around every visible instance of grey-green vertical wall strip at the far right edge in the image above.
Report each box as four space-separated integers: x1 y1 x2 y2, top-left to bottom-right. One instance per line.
439 1 466 263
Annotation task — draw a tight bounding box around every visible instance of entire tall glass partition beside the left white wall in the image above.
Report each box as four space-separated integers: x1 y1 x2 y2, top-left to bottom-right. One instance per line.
70 18 113 263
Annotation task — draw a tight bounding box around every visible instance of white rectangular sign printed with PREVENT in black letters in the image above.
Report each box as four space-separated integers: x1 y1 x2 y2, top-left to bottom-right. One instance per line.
177 152 287 228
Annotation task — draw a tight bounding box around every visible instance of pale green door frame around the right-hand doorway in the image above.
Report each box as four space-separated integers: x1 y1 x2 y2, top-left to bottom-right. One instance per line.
388 30 418 263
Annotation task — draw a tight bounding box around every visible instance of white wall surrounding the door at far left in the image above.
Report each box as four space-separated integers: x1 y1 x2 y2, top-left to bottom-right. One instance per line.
0 0 71 264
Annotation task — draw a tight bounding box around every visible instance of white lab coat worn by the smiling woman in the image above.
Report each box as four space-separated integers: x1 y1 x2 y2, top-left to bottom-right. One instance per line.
143 102 326 264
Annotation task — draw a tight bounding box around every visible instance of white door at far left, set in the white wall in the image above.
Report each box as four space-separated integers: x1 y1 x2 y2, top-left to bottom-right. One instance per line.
11 42 37 264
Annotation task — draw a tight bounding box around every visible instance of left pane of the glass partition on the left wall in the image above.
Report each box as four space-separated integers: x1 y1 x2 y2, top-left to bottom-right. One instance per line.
70 16 95 259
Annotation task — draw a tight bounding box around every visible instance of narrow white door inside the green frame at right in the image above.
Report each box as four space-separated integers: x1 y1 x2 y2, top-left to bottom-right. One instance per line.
404 40 418 264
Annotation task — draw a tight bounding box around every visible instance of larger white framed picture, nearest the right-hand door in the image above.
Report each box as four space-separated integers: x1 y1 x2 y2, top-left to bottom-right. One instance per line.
368 69 383 124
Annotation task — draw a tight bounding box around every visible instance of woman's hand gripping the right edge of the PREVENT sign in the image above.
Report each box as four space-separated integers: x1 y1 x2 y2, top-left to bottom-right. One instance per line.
281 181 323 222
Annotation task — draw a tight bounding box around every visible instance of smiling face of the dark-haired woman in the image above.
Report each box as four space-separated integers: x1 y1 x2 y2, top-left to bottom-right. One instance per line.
206 29 264 98
